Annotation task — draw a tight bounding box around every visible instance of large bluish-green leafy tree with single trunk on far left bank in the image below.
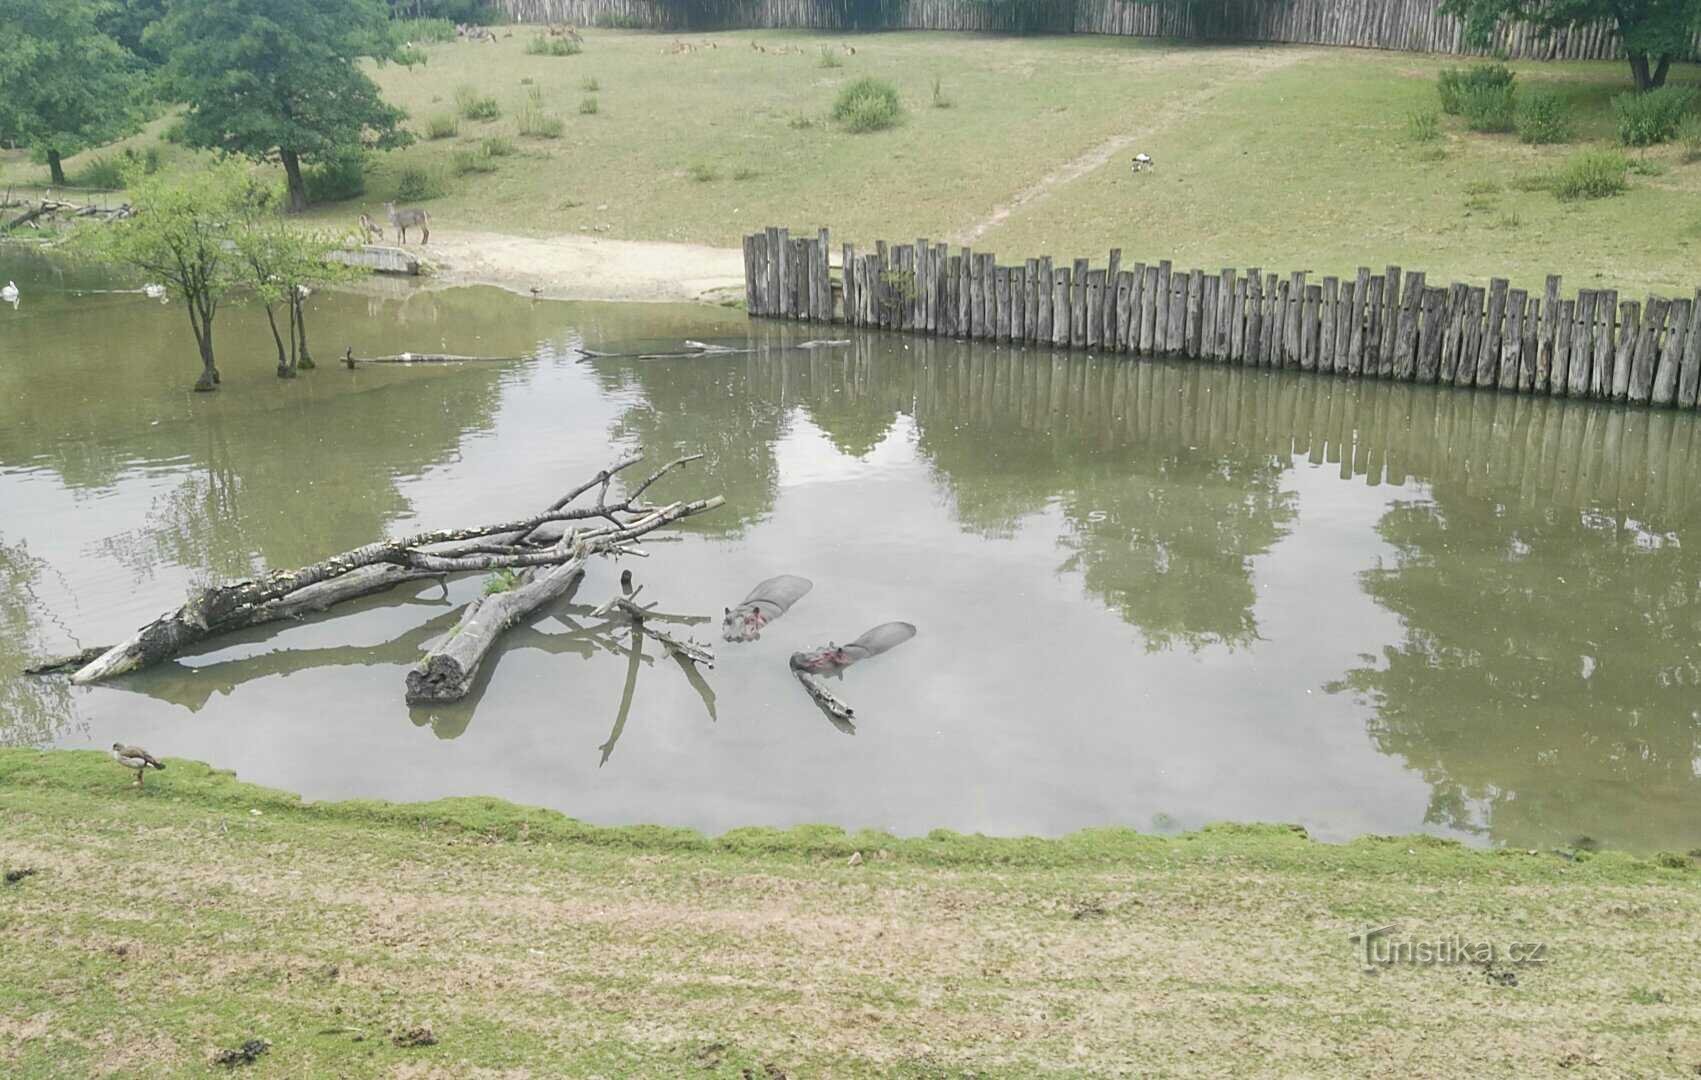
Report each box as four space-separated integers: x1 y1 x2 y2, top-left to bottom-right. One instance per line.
146 0 412 211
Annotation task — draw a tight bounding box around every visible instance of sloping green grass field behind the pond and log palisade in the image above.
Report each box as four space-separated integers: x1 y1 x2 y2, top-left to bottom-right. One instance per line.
0 27 1701 291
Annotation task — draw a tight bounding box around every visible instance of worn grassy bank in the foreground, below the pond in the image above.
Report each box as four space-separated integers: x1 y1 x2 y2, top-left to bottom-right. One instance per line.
0 750 1701 1077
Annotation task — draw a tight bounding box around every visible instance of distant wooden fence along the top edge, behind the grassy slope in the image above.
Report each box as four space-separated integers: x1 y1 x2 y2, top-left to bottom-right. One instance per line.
492 0 1701 60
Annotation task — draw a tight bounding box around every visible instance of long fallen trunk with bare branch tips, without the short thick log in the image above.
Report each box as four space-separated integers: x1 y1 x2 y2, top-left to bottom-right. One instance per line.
71 454 721 685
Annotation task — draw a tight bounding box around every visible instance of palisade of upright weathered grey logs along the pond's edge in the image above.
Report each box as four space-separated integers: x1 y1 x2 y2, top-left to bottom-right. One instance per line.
743 228 1701 408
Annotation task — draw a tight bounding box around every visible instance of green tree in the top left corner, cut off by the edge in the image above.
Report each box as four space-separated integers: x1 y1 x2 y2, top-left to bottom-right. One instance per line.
0 0 141 184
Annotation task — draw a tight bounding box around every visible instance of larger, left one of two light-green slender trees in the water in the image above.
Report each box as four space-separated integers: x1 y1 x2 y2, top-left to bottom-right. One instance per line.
77 162 253 391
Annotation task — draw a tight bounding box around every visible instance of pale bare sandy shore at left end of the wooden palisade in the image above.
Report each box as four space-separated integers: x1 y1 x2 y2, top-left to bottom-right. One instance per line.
408 228 743 303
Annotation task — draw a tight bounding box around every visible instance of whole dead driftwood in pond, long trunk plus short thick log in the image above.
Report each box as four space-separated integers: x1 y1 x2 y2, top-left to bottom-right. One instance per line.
51 454 723 701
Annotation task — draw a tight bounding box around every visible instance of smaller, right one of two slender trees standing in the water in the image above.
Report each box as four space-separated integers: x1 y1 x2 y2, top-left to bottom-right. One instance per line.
235 199 359 379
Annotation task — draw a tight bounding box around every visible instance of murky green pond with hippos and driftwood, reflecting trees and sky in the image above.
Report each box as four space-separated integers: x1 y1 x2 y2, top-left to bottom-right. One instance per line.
0 252 1701 850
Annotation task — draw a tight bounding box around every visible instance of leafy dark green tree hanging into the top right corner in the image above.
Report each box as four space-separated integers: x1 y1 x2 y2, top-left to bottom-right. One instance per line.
1441 0 1701 90
